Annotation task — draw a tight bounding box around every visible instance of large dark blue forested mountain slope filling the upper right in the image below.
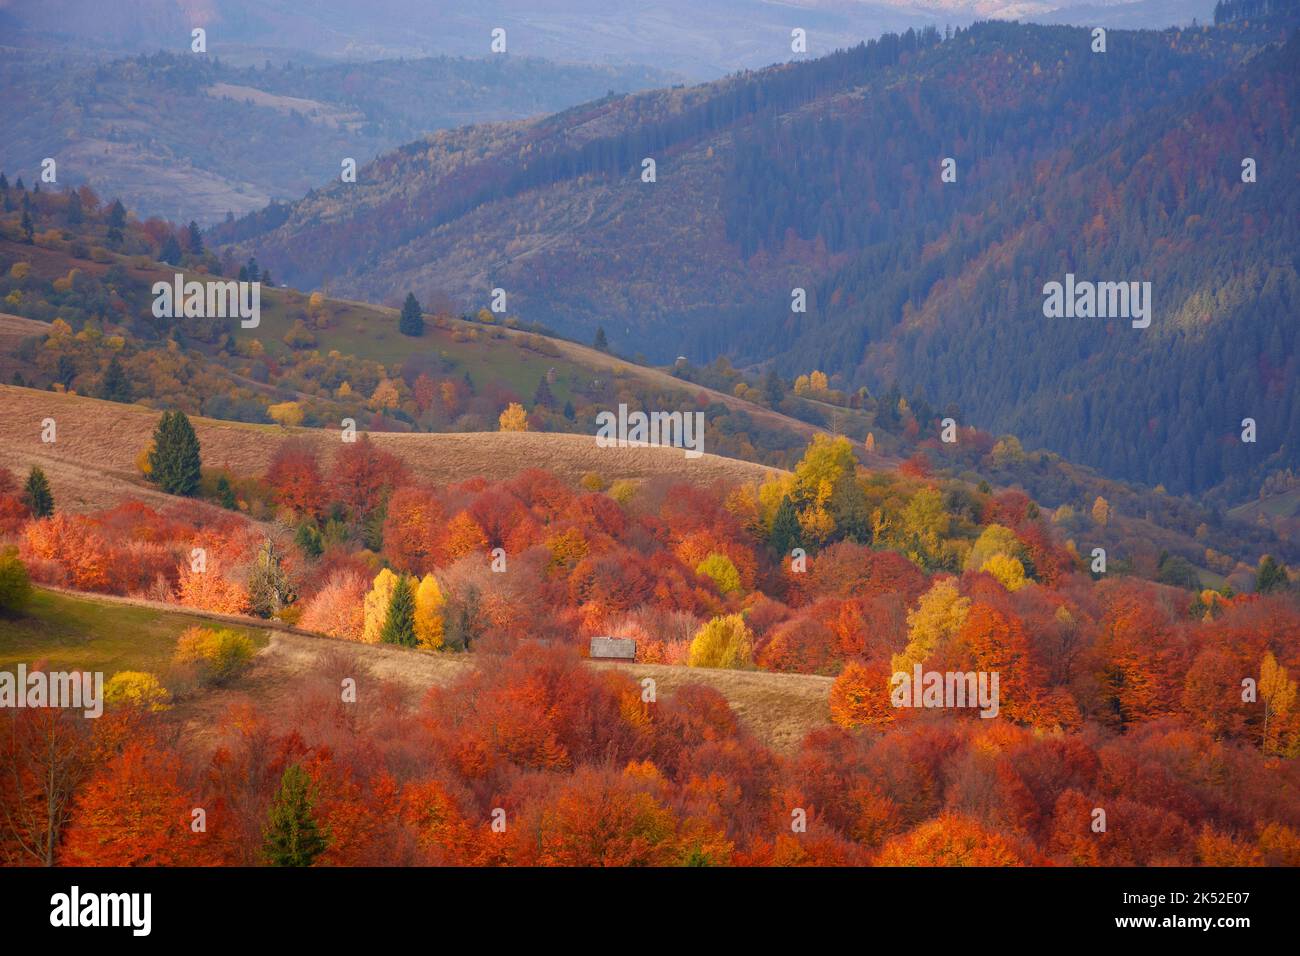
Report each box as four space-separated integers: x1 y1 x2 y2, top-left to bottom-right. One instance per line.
223 13 1300 496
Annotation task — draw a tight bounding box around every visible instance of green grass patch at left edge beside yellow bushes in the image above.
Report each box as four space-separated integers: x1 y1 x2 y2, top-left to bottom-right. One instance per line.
0 591 268 679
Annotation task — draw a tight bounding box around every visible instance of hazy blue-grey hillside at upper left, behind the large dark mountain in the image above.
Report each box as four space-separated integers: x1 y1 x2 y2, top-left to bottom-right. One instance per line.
0 51 671 224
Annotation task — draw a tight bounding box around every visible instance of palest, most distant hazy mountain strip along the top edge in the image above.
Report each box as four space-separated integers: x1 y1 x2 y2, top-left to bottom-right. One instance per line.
0 0 1214 81
